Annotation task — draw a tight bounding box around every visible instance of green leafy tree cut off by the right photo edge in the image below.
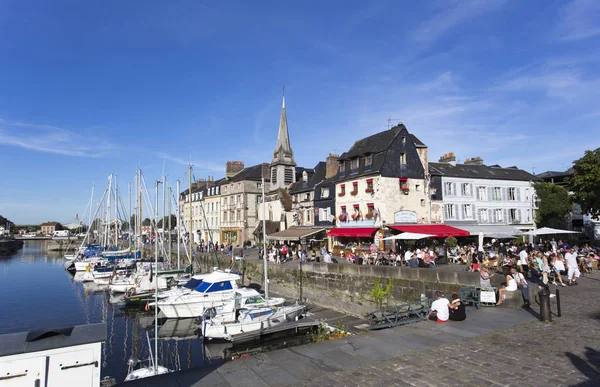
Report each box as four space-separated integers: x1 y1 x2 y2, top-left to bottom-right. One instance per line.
569 148 600 216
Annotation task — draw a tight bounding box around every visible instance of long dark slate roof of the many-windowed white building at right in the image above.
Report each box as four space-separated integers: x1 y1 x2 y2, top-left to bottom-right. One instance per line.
429 163 539 181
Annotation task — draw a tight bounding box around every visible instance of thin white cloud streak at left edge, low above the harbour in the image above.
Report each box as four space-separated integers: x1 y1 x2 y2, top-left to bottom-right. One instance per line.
0 118 116 157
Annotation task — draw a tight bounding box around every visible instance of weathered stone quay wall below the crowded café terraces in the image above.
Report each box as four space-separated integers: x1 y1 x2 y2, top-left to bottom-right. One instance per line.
209 259 479 317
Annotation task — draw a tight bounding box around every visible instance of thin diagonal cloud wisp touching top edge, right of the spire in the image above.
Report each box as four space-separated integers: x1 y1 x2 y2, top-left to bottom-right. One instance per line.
413 0 506 43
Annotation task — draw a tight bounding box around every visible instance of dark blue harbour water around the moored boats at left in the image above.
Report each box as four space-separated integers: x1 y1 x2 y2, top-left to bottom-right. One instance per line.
0 241 314 382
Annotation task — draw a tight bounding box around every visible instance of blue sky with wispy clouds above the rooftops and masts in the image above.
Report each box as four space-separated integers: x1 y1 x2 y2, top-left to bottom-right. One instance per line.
0 0 600 224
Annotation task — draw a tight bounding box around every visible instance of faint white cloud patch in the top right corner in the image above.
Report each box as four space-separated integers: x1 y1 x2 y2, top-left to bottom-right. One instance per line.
557 0 600 41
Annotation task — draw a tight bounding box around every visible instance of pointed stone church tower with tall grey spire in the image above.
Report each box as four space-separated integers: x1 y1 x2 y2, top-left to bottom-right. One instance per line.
271 96 296 190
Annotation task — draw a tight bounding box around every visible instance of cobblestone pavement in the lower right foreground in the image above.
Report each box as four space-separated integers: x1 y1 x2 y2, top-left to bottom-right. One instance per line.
303 274 600 387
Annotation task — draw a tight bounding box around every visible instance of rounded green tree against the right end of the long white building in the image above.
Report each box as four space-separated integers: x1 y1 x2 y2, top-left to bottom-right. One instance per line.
533 181 572 227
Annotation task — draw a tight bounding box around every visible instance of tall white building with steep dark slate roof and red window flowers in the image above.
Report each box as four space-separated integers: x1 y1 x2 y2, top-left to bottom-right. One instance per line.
335 124 429 227
